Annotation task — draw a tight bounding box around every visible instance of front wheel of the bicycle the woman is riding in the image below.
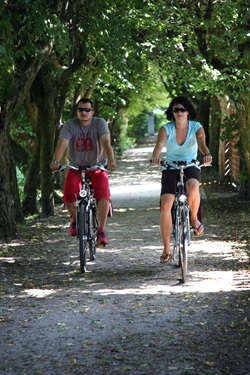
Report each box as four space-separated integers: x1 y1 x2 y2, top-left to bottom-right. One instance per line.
180 209 189 283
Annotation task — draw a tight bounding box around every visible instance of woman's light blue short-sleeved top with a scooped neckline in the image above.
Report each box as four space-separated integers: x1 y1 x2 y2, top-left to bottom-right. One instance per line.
164 121 202 169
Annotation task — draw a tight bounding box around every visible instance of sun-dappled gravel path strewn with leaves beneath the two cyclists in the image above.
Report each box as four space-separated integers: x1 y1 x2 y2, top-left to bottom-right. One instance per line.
0 140 250 375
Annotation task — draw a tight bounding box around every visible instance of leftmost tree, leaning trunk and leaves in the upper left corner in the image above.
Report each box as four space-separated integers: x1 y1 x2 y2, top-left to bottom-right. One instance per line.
0 1 63 240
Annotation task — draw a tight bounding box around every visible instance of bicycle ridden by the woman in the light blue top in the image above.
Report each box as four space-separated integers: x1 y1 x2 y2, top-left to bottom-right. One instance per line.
156 160 203 283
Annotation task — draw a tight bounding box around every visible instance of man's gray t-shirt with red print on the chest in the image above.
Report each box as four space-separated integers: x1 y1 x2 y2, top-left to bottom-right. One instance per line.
60 117 110 167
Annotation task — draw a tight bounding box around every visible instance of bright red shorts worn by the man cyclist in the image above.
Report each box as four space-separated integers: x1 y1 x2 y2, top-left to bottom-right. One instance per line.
63 169 110 203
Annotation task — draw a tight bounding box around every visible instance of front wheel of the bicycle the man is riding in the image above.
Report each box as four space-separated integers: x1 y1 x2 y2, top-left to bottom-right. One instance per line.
77 204 88 272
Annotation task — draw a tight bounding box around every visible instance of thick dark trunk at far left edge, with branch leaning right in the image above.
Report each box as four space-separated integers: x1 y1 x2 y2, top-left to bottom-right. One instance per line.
0 52 50 241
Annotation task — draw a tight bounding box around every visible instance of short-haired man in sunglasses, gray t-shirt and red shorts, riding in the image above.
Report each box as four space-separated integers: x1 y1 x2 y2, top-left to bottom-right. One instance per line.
50 98 116 246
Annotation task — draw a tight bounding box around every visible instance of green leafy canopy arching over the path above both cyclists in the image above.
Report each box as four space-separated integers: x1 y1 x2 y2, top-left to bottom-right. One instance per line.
0 0 250 206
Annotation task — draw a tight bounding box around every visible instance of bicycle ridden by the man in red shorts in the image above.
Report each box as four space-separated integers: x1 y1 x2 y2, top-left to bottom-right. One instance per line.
53 164 106 273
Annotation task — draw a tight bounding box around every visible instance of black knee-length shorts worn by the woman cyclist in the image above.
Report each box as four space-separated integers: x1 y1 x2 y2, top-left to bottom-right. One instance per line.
161 167 201 195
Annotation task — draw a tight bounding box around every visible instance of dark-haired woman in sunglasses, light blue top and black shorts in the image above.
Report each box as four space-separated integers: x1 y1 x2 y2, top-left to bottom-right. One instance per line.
151 96 212 263
